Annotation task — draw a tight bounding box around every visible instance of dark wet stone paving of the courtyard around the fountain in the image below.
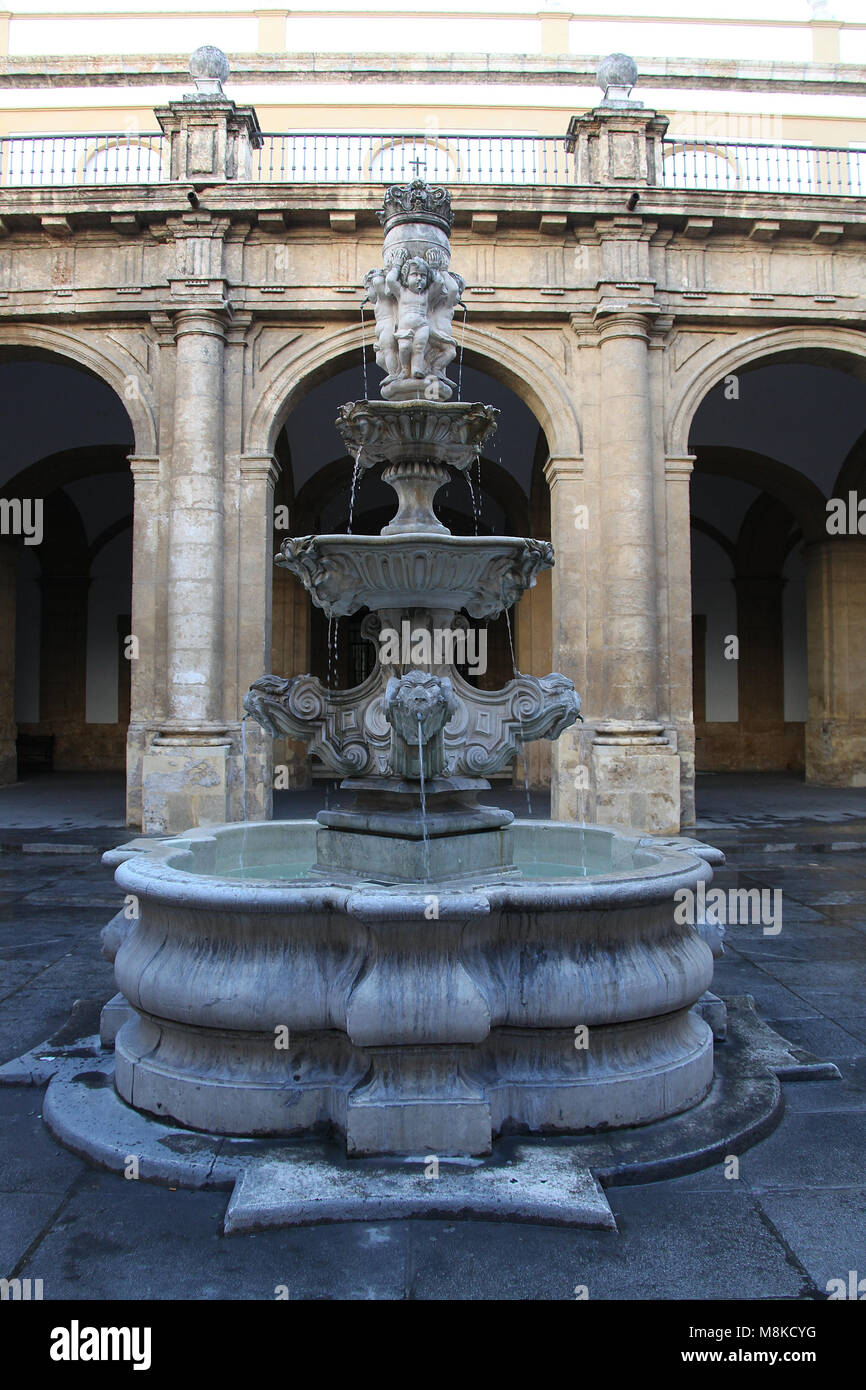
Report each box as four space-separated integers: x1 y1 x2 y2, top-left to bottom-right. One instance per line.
0 778 866 1300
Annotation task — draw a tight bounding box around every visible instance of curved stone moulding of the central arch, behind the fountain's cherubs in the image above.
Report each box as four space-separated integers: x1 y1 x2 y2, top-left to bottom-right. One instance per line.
246 322 581 459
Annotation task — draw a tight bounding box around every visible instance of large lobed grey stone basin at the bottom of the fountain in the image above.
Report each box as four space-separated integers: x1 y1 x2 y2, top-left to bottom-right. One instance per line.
108 821 713 1155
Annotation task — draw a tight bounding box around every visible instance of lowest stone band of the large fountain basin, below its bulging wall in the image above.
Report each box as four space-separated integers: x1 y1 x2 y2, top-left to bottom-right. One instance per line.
109 1005 713 1156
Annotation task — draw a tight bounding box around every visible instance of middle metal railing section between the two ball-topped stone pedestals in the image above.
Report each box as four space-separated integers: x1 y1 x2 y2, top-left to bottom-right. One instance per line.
253 133 574 186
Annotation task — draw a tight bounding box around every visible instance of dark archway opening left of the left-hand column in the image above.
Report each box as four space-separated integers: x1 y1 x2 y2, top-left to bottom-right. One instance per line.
0 346 135 780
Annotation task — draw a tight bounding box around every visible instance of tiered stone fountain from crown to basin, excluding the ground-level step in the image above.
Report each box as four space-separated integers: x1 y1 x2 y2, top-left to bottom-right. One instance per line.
96 181 713 1155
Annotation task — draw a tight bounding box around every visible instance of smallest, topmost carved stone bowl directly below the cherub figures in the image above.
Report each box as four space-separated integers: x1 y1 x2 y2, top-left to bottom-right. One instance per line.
336 400 499 473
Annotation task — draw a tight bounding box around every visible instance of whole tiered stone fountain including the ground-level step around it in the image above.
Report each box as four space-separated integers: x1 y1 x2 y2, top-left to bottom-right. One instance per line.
18 179 838 1232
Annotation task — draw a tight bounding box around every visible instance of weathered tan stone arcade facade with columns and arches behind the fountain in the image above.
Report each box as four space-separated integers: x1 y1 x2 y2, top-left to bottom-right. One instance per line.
0 56 866 833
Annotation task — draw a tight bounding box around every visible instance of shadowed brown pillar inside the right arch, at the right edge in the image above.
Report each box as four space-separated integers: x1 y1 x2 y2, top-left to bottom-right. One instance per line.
806 537 866 787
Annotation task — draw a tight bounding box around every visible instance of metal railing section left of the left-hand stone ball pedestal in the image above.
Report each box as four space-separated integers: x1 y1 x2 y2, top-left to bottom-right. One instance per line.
0 132 171 188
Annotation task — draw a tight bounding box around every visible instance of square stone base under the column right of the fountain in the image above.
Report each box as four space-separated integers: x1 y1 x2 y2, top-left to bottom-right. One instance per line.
589 720 681 835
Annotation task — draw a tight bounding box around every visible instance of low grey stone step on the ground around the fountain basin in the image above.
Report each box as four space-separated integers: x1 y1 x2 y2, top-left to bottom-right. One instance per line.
33 995 840 1232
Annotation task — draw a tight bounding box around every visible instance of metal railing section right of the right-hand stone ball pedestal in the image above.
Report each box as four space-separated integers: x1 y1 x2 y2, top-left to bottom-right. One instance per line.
662 138 866 197
